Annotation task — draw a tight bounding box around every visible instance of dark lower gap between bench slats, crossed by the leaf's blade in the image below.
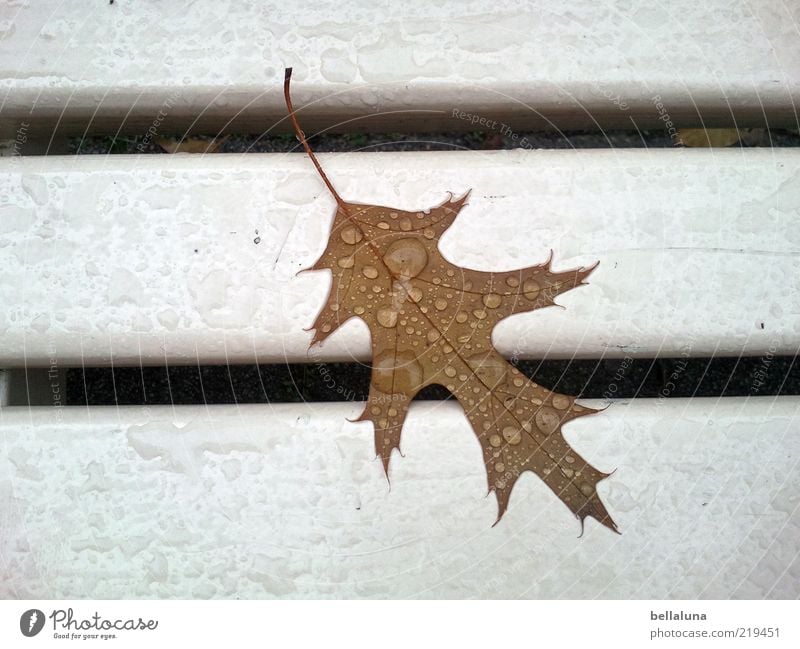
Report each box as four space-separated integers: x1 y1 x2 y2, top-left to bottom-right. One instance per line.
66 355 800 405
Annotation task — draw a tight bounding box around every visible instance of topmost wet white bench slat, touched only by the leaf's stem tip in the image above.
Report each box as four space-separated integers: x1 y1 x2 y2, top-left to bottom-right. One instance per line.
0 0 800 140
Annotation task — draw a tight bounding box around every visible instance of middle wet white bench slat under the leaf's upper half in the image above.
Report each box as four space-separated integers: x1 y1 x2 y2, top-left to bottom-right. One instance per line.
0 149 800 367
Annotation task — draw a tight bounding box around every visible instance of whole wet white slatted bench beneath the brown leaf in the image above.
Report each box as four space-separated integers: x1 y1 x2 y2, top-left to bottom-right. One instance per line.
0 2 800 598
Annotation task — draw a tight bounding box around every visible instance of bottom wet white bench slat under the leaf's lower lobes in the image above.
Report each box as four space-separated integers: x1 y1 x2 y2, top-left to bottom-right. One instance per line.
0 397 800 599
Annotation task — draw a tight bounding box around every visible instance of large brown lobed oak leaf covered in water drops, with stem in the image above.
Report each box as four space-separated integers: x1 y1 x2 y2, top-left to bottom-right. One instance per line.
285 69 617 531
